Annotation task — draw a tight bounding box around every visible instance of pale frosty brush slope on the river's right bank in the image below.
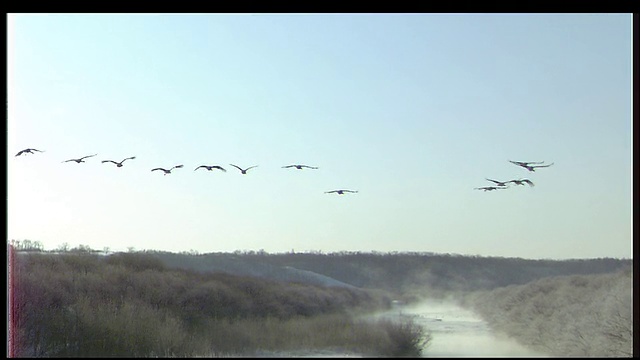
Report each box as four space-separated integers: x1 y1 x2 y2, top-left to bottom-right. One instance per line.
463 266 633 357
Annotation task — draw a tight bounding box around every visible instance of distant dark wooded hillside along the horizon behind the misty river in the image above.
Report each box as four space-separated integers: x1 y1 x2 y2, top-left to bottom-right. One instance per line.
144 251 631 301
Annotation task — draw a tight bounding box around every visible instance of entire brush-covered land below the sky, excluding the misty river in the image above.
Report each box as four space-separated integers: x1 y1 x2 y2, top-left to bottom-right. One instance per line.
10 241 632 357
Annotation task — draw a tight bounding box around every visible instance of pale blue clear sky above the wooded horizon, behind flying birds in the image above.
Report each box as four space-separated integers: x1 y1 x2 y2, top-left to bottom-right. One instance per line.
7 14 632 259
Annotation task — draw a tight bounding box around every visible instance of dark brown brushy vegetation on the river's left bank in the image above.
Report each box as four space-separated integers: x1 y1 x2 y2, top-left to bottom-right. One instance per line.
10 252 424 357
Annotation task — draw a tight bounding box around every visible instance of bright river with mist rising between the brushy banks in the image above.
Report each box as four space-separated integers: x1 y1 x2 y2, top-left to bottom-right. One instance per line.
388 300 548 357
